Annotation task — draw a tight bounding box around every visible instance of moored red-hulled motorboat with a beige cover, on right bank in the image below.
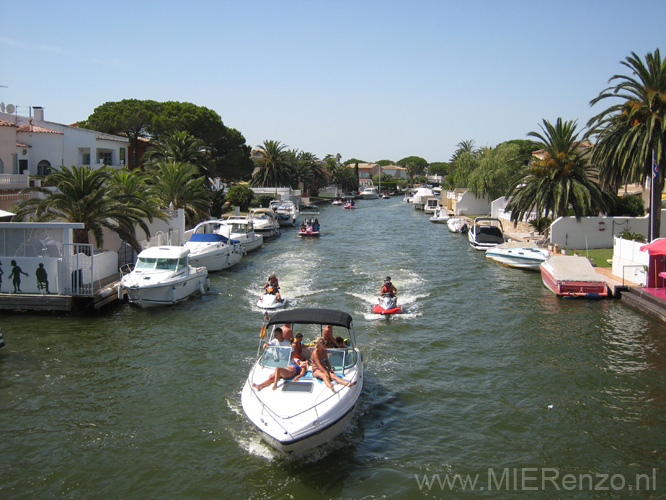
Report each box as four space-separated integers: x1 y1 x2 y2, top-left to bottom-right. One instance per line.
539 254 608 299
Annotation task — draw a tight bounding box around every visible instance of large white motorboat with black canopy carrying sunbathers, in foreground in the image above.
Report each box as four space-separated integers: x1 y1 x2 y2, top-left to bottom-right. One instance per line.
241 309 363 454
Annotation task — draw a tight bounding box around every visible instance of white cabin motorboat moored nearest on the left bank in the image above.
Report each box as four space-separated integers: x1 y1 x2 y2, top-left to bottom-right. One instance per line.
118 246 208 308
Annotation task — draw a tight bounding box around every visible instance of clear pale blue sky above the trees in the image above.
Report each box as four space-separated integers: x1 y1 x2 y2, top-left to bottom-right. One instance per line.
0 0 666 162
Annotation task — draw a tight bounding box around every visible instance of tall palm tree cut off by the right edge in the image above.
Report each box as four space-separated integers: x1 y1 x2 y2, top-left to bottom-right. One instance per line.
589 49 666 239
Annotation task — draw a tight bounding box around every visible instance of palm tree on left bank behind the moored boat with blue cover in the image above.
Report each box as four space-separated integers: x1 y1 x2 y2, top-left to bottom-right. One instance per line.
148 160 210 224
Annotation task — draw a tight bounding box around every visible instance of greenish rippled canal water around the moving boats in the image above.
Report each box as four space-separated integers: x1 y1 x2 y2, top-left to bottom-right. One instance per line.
0 198 666 500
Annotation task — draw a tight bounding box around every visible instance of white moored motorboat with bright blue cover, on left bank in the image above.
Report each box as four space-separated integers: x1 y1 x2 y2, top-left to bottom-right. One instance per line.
185 220 245 272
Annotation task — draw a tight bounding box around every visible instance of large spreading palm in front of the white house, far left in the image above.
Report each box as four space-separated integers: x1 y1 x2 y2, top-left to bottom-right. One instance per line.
14 166 149 248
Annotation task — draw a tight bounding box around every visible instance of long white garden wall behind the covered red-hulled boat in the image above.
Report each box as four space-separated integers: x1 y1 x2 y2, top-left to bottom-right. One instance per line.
550 210 666 249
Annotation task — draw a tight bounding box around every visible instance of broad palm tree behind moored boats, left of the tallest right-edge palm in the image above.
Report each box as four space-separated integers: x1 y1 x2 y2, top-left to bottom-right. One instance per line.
507 118 609 222
